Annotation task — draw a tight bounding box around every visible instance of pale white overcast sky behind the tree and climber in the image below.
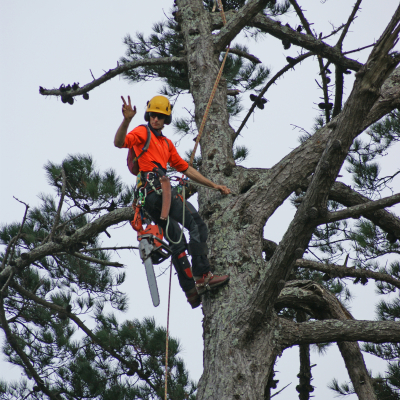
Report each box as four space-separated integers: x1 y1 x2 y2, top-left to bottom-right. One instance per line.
0 0 398 399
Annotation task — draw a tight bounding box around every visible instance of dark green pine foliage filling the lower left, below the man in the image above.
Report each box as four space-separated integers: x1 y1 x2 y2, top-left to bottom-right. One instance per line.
0 155 196 400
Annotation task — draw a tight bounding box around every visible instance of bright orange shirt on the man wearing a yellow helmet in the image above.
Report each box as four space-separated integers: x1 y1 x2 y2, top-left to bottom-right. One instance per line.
122 125 189 172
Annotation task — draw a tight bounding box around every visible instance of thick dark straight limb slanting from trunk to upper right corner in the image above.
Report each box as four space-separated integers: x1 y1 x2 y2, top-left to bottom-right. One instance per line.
237 7 400 340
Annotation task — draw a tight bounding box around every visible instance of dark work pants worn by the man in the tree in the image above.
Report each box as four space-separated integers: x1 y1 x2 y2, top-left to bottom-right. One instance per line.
144 189 211 292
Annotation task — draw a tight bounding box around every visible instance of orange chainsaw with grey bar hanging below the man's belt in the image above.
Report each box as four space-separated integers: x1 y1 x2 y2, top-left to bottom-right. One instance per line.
131 205 171 307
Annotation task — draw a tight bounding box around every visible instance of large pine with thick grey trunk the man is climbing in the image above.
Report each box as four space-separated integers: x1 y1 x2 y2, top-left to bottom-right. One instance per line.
18 0 400 399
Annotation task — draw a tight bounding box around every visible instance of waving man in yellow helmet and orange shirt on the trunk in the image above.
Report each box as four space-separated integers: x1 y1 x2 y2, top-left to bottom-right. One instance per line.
114 96 230 308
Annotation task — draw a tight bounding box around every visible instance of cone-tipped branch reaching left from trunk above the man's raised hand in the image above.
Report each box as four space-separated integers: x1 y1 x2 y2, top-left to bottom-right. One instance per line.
39 57 186 97
